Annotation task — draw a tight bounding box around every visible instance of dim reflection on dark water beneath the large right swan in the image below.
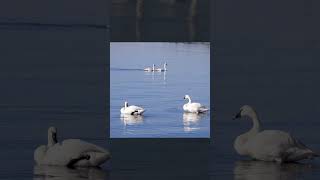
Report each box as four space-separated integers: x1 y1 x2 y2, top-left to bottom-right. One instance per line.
233 160 314 180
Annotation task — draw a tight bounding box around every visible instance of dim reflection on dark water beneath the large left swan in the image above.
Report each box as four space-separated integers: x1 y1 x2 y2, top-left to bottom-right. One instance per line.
33 165 109 180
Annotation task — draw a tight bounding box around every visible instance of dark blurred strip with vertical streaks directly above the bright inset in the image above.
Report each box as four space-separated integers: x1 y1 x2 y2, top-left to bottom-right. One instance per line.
111 0 210 42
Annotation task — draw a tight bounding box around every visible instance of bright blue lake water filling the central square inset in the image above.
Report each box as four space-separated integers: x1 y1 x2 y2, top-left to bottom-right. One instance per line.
110 43 210 138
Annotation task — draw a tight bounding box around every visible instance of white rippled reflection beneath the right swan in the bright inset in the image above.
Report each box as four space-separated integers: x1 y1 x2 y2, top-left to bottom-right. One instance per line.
183 112 204 132
